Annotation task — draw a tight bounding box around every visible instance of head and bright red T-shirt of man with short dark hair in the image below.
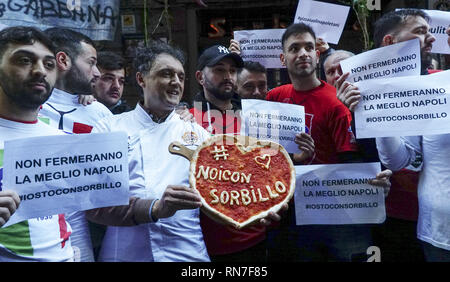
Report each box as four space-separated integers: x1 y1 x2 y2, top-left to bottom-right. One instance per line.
267 24 357 164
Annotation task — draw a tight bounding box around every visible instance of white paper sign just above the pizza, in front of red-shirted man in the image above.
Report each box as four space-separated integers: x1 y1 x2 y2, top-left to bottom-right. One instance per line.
241 99 305 153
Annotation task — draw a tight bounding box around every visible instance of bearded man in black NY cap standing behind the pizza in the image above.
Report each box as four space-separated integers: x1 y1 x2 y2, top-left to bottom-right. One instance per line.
190 45 266 262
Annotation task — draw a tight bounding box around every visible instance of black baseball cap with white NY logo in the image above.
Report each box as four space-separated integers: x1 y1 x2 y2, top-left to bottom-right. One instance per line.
197 45 244 70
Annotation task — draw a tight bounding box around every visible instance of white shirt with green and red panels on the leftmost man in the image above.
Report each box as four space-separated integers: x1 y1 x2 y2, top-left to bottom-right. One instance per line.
0 118 73 262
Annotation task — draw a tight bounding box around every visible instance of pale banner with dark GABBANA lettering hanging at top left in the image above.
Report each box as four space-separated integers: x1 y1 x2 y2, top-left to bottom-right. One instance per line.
0 0 120 40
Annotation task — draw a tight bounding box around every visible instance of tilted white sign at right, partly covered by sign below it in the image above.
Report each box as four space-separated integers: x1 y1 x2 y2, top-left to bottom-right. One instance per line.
340 39 420 83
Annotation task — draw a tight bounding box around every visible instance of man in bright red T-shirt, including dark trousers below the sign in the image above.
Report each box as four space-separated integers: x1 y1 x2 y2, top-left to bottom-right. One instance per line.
267 23 384 261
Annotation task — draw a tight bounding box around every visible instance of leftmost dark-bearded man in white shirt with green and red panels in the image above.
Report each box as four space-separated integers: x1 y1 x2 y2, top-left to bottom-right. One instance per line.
0 27 74 262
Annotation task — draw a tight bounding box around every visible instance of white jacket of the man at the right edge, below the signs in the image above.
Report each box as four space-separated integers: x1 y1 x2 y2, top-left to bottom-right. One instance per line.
377 134 450 250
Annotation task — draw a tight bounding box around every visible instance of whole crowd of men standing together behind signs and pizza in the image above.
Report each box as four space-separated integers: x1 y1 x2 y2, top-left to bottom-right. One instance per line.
0 9 450 262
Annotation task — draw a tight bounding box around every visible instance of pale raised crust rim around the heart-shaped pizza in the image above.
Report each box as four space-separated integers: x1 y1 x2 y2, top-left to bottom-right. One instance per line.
189 135 295 229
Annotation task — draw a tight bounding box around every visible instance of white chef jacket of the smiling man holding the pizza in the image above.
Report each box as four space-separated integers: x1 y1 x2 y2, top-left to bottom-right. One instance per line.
94 104 210 262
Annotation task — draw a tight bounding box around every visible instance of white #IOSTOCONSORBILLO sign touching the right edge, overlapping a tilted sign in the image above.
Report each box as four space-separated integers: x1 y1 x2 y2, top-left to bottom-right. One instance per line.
355 70 450 138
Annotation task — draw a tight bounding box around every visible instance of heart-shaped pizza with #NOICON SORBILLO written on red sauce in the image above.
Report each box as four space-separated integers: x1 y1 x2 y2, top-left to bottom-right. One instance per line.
179 135 295 228
